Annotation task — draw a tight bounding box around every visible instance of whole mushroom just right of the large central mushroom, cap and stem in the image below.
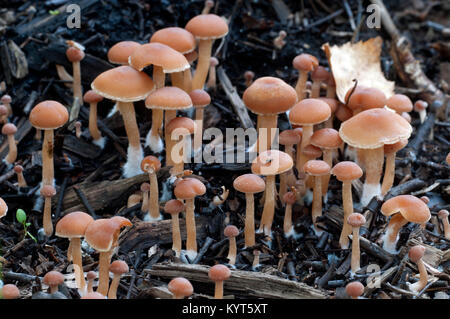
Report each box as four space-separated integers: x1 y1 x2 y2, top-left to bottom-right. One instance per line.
289 99 331 172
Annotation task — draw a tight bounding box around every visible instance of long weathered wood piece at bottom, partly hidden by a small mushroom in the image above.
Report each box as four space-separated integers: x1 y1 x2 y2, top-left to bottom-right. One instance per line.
145 263 328 299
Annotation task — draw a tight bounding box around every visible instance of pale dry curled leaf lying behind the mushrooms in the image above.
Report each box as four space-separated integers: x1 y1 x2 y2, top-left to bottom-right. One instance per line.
322 37 395 103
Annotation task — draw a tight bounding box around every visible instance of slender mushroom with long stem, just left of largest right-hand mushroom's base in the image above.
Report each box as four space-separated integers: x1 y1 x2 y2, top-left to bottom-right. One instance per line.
331 161 363 249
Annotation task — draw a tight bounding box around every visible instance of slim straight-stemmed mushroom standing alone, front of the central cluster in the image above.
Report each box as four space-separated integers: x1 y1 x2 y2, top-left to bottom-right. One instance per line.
233 174 266 247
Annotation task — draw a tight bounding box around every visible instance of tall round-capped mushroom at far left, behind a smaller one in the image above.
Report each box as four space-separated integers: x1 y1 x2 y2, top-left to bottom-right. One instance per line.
29 100 69 185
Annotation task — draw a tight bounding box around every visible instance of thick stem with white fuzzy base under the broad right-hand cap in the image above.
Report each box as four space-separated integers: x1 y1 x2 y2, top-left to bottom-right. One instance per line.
361 146 384 206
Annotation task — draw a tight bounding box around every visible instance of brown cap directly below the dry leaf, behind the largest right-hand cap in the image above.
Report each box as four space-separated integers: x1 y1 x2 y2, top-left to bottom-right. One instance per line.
345 86 387 110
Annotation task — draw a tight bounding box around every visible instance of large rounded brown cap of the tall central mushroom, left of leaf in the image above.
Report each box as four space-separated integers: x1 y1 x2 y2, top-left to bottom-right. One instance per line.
242 76 297 115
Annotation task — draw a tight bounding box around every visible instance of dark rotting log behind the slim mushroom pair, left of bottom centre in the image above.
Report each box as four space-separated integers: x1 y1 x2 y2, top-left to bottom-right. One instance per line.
119 218 208 253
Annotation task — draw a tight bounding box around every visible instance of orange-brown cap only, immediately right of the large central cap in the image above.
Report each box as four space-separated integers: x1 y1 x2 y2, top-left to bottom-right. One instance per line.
289 99 331 125
